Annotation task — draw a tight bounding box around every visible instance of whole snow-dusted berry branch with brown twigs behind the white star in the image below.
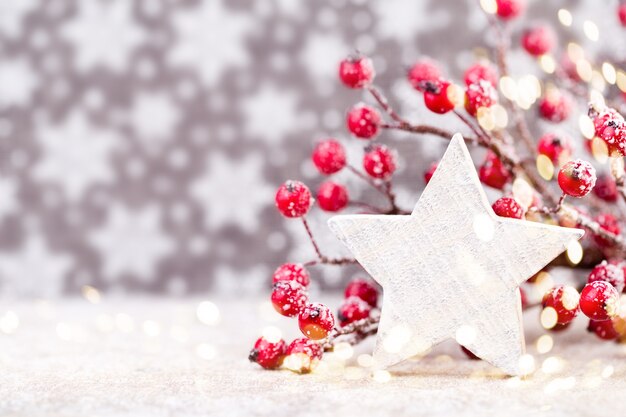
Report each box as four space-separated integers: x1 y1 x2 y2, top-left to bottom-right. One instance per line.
250 0 626 373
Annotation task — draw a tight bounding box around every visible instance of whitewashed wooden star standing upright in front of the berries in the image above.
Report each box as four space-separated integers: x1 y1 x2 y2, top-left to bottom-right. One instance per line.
329 134 584 375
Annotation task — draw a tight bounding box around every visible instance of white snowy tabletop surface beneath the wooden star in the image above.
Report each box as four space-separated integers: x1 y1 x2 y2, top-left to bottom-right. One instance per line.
0 296 626 417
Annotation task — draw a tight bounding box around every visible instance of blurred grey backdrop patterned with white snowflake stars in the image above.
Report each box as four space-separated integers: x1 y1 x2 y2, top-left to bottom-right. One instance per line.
0 0 626 297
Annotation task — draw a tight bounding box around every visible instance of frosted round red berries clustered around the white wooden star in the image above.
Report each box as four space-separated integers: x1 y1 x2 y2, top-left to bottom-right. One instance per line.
250 0 626 373
